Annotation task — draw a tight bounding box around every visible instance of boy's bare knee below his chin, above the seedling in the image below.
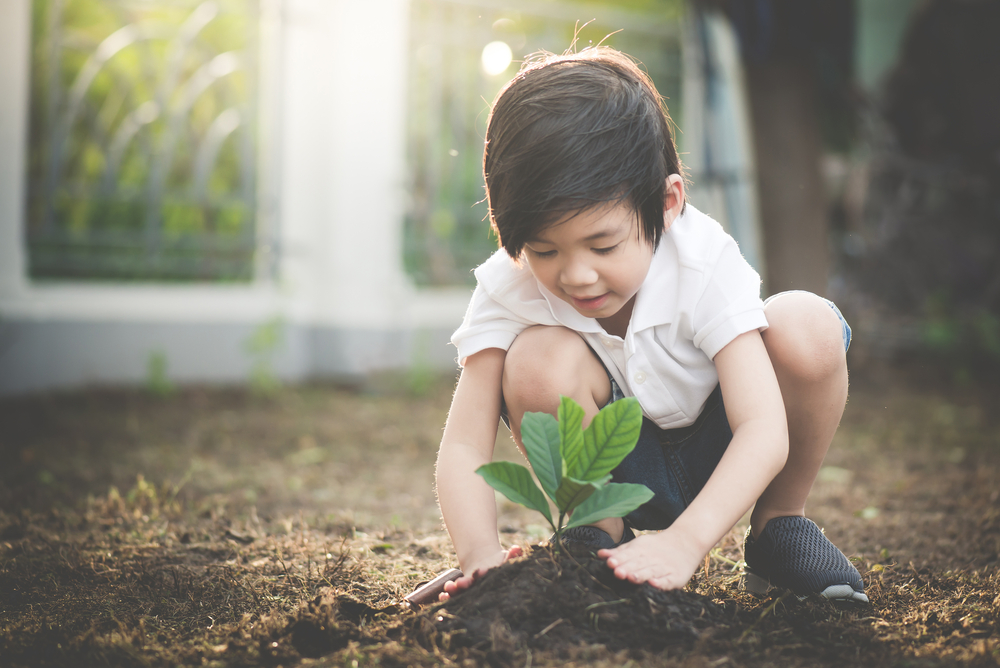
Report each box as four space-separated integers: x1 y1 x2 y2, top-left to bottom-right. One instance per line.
503 326 610 412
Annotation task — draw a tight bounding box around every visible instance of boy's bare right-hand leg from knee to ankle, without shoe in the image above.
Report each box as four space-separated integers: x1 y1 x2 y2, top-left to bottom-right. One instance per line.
750 292 847 536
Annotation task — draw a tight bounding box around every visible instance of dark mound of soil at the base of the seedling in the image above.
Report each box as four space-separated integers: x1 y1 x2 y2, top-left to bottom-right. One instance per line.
406 548 738 658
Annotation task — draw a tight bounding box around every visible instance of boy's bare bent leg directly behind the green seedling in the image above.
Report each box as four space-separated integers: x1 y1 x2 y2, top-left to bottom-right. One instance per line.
503 325 624 543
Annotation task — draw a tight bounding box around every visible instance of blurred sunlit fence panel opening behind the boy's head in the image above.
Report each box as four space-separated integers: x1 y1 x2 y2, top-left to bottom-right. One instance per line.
404 0 682 285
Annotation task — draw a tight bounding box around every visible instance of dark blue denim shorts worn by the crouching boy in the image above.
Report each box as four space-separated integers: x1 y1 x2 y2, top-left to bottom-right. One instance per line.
608 295 851 530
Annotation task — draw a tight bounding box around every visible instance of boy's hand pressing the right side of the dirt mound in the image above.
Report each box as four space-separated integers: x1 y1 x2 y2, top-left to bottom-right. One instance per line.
597 529 705 589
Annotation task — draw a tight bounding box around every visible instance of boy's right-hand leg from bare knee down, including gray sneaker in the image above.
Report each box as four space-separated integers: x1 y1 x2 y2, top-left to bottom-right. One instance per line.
744 292 868 602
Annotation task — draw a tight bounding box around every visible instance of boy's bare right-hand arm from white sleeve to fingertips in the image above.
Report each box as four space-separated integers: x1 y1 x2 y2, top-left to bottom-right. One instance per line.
598 330 788 589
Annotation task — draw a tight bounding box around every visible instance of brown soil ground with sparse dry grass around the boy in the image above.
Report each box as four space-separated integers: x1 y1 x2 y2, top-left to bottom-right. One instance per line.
0 368 1000 667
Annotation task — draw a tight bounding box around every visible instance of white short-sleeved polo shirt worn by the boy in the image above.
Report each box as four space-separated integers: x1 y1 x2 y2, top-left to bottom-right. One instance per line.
451 204 767 429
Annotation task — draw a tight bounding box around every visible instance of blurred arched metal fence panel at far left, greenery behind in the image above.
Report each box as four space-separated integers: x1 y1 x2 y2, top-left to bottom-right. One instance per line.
26 0 259 281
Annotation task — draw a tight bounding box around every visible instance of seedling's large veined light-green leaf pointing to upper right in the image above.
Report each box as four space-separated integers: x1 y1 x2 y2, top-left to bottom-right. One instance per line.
566 397 642 480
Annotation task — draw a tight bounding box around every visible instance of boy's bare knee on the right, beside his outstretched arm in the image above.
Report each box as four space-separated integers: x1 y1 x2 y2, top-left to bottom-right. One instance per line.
763 292 847 383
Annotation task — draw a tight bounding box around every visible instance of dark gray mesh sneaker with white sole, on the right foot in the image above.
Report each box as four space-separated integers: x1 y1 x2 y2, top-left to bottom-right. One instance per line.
743 517 868 603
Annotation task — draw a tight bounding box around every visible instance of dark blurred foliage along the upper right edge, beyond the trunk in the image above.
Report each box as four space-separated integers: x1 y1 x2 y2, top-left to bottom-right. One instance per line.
840 0 1000 380
